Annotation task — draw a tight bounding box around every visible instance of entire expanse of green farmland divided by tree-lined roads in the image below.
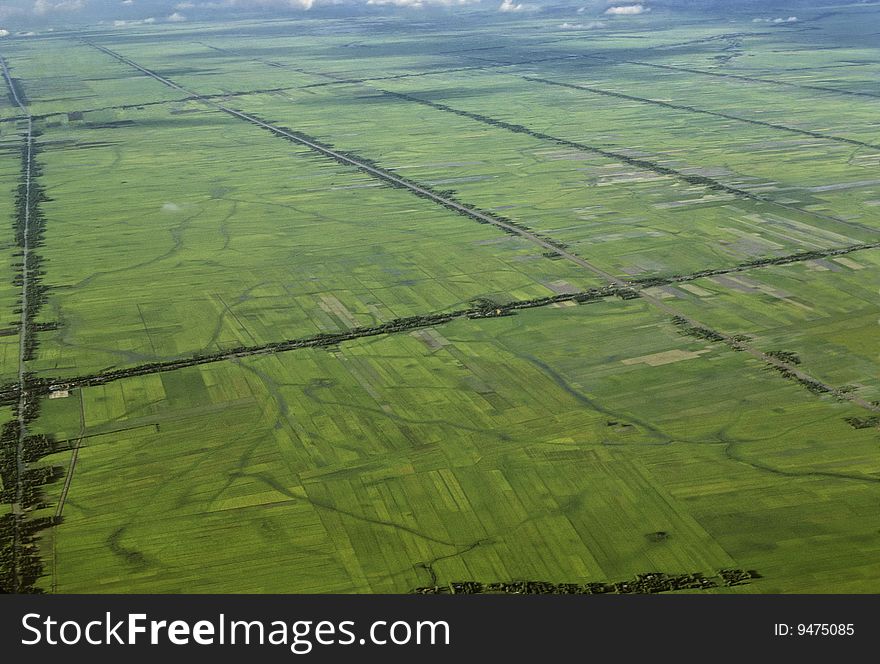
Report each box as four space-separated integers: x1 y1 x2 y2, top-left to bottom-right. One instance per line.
0 5 880 593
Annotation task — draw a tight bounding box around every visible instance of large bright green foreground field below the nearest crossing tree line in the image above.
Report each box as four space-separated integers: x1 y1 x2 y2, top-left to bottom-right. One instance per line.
41 301 880 592
